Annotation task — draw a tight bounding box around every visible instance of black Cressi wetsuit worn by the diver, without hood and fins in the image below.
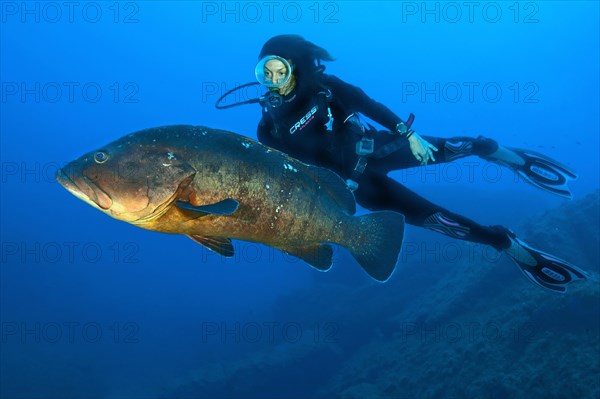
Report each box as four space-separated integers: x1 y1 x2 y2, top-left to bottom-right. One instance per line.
257 74 510 250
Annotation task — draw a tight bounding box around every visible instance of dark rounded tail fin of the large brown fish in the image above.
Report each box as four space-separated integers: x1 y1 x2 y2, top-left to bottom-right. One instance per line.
345 211 404 282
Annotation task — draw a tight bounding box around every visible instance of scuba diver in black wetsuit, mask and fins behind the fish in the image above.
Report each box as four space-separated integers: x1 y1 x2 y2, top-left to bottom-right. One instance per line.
216 35 588 292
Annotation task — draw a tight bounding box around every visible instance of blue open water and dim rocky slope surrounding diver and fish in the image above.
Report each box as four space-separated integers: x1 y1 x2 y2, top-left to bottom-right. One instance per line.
0 1 600 399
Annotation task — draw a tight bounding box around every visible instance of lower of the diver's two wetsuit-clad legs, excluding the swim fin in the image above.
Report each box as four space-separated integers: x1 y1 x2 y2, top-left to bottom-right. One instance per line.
354 173 511 251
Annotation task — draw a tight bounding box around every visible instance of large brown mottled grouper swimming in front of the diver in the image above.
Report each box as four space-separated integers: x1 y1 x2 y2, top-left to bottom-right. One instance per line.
56 126 404 281
